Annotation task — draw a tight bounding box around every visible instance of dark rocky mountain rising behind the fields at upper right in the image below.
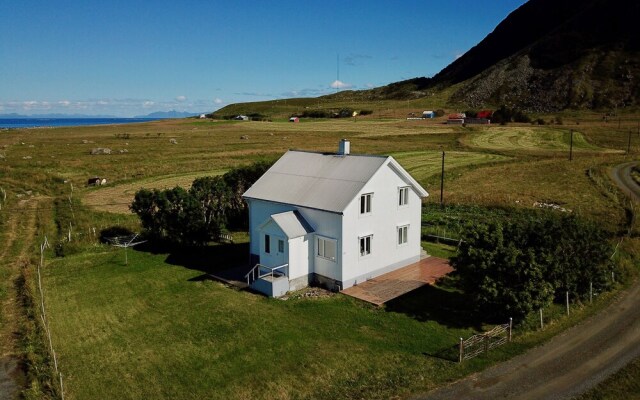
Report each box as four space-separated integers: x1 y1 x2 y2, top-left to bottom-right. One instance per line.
442 0 640 111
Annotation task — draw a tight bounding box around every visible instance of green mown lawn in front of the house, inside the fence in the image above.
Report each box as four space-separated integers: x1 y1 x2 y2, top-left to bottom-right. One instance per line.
44 246 506 399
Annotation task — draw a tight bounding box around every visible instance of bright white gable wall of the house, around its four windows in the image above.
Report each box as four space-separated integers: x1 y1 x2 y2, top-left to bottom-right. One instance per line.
341 159 422 288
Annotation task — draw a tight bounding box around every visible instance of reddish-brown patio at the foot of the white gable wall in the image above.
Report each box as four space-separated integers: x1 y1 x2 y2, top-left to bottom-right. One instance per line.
342 257 453 306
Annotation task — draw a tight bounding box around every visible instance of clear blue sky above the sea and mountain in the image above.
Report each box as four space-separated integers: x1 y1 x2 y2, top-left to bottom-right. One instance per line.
0 0 525 117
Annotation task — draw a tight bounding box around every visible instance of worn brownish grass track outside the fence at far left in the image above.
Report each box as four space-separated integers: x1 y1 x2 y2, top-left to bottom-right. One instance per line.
0 200 37 399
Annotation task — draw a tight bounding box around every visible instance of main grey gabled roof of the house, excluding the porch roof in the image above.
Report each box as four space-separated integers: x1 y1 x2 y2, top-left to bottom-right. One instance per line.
243 150 428 213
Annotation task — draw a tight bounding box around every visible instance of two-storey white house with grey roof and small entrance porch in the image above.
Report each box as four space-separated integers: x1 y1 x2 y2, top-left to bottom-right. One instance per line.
243 139 428 297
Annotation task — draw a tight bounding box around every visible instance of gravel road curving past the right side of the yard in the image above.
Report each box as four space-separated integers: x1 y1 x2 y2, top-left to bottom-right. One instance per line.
414 162 640 400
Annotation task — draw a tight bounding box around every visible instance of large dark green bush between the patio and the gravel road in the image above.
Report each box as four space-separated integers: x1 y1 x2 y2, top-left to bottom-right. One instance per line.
452 213 613 319
